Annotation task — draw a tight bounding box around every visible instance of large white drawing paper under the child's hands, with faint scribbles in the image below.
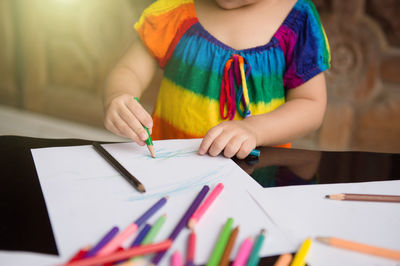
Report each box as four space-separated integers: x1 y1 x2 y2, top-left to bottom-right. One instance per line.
0 139 291 265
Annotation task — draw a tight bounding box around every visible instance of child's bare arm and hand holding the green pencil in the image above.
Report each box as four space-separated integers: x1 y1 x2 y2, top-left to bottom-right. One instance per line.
104 41 157 145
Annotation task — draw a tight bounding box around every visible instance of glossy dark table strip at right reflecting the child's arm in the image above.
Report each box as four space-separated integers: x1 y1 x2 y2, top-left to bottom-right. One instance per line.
235 147 400 188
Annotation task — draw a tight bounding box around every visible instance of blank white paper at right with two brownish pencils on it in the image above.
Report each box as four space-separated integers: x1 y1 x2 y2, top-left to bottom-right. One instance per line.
255 181 400 266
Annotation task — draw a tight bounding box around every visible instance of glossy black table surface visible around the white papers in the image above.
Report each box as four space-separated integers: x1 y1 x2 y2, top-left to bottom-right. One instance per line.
0 136 400 265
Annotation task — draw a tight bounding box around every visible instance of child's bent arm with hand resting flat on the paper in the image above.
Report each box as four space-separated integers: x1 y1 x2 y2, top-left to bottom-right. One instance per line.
199 73 326 159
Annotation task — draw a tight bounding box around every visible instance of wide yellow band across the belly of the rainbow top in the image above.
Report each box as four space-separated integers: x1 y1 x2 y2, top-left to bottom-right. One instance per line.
154 78 285 136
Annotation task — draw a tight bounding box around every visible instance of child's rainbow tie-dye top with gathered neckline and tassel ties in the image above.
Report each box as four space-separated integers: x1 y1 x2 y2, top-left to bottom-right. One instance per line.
135 0 330 139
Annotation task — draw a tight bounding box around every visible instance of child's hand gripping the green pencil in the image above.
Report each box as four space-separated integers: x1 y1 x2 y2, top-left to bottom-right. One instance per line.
104 94 153 146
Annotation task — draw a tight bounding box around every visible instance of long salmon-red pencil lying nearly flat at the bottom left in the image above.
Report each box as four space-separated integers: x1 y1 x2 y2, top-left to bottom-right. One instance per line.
64 239 172 266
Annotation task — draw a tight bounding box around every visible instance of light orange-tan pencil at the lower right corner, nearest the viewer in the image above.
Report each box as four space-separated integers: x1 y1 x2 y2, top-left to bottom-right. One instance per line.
316 237 400 260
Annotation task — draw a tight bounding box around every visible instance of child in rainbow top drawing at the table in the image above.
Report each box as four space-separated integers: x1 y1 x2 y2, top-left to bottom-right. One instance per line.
104 0 330 158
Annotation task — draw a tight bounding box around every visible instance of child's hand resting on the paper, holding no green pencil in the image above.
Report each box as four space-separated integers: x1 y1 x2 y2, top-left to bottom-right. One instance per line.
199 120 256 159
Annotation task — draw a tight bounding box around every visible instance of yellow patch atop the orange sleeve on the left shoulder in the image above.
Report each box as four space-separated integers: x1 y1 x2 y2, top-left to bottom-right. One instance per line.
134 0 193 30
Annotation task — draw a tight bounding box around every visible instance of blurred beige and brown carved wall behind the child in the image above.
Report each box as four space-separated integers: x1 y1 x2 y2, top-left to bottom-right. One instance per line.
0 0 400 152
